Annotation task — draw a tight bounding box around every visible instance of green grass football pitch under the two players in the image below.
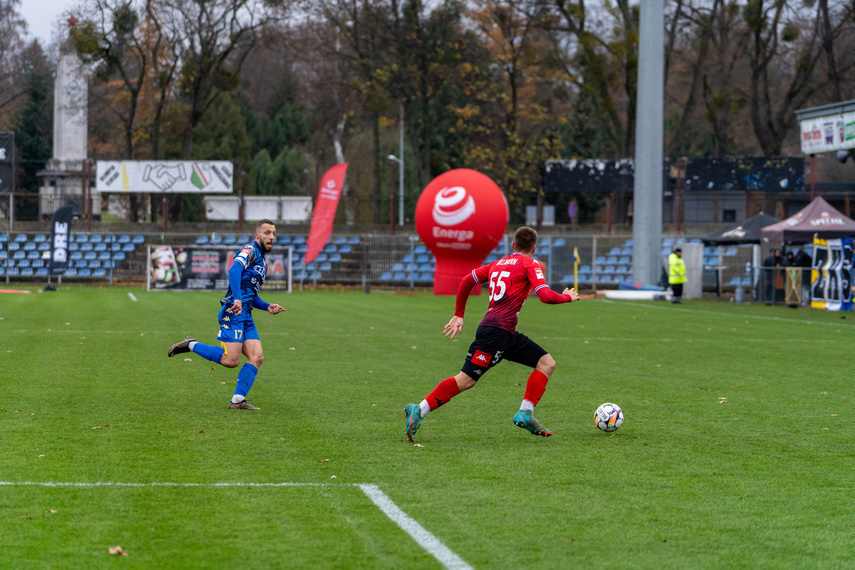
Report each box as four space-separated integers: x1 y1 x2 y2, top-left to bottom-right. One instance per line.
0 286 855 568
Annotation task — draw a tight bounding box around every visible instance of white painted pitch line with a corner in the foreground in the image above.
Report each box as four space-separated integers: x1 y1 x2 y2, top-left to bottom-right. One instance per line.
0 481 472 570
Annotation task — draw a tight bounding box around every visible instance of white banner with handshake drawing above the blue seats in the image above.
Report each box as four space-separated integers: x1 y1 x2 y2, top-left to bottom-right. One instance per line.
95 160 234 194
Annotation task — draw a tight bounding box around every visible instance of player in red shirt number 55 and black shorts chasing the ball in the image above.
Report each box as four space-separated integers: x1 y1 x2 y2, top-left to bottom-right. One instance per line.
404 227 579 441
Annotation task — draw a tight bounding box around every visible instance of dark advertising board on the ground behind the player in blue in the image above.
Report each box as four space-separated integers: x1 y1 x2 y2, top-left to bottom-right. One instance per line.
148 245 291 293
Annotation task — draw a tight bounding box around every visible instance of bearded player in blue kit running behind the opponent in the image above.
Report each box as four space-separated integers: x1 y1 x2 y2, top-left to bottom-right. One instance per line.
168 220 285 410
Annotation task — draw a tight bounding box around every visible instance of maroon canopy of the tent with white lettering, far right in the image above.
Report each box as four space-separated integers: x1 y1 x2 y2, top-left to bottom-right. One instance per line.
761 198 855 244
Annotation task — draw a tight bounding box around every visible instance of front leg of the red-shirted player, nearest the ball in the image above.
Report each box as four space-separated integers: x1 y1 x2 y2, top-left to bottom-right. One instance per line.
505 333 555 437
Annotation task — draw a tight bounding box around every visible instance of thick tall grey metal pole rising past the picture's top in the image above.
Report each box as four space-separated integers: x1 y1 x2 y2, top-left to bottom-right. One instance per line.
632 0 665 285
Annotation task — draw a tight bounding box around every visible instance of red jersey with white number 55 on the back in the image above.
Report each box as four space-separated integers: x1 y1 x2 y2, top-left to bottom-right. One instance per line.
454 253 572 332
